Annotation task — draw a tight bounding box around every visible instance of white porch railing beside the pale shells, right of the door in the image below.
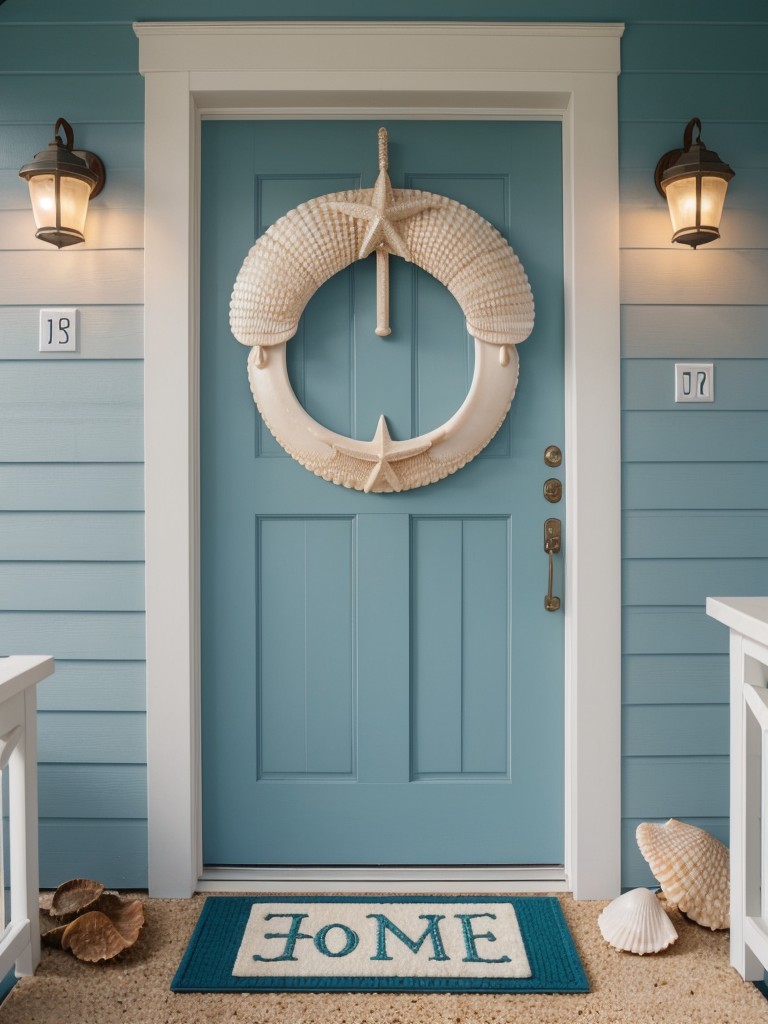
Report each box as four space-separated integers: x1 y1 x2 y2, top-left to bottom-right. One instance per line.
707 597 768 981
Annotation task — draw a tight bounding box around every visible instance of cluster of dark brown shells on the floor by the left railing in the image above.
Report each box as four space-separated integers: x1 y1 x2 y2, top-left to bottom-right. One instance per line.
40 879 144 964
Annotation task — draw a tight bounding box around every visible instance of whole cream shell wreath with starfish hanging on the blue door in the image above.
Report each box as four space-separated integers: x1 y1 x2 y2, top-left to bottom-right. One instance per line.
229 129 534 493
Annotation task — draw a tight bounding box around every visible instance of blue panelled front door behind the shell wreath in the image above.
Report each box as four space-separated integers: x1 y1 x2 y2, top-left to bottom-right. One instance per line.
201 121 564 865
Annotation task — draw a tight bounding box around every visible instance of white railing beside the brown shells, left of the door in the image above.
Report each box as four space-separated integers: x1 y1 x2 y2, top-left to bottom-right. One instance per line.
0 656 53 979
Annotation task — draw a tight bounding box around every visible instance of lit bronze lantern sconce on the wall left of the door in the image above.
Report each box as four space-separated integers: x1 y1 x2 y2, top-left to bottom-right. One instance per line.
18 118 106 249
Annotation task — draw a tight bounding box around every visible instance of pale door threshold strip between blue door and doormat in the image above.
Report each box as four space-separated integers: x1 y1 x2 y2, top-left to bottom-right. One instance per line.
197 864 570 894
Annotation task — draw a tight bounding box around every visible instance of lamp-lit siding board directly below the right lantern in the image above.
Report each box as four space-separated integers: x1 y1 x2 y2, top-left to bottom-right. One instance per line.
622 246 768 305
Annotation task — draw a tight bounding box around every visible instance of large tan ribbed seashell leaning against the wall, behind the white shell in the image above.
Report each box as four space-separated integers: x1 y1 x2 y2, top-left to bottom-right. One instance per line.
636 818 730 931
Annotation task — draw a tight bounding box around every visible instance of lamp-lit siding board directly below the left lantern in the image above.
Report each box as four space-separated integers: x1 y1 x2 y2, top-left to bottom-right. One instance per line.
0 246 143 306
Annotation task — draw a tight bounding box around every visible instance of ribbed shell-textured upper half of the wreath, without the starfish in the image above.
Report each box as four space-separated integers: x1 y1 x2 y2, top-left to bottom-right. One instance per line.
229 188 534 346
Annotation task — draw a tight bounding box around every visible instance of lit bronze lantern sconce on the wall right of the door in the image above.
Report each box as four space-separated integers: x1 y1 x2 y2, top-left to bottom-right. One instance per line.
654 118 735 249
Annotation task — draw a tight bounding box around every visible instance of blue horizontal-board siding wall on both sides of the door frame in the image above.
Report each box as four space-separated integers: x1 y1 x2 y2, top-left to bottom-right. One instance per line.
0 0 768 886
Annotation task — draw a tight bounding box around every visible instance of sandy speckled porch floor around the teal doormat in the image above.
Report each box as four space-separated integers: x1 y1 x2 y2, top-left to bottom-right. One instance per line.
0 896 768 1024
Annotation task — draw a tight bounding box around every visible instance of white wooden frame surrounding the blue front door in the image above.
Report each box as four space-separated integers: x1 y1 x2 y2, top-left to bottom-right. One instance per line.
134 22 624 899
